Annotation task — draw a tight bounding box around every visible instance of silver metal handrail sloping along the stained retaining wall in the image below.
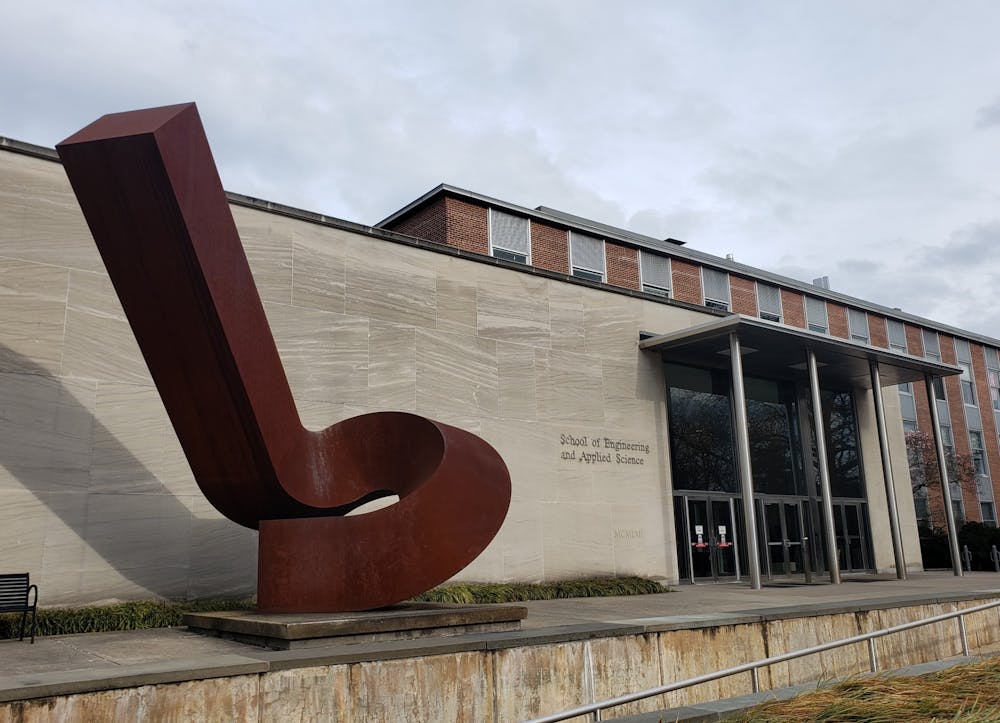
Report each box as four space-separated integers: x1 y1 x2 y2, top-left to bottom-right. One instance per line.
527 600 1000 723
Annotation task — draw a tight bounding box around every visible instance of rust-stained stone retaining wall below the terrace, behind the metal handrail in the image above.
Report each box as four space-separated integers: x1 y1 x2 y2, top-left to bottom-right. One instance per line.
0 600 1000 723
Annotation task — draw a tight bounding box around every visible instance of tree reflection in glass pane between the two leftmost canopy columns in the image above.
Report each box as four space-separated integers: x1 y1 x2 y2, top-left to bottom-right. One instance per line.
747 399 796 494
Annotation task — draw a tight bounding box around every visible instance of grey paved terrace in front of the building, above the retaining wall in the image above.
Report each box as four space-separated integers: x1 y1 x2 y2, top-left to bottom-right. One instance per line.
0 572 1000 701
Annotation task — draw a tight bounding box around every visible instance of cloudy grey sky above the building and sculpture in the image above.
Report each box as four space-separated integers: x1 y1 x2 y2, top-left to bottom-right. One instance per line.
0 0 1000 337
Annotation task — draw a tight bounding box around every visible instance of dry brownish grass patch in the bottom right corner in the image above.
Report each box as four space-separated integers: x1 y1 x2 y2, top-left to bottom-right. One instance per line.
731 658 1000 723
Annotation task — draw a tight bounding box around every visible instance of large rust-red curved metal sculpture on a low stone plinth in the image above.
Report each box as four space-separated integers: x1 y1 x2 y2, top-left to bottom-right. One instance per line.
57 104 510 612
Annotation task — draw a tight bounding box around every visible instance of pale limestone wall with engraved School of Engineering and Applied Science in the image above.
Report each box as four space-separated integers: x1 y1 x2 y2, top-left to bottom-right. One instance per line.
0 147 708 605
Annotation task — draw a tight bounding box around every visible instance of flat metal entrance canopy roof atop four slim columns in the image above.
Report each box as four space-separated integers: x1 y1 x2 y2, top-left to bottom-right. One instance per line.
639 314 962 389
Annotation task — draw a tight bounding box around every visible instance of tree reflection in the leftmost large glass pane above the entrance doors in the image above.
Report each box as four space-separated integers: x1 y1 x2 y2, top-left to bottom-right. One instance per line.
670 388 738 492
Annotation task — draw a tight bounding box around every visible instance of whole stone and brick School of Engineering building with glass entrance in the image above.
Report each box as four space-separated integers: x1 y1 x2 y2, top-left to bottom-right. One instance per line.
0 139 1000 605
